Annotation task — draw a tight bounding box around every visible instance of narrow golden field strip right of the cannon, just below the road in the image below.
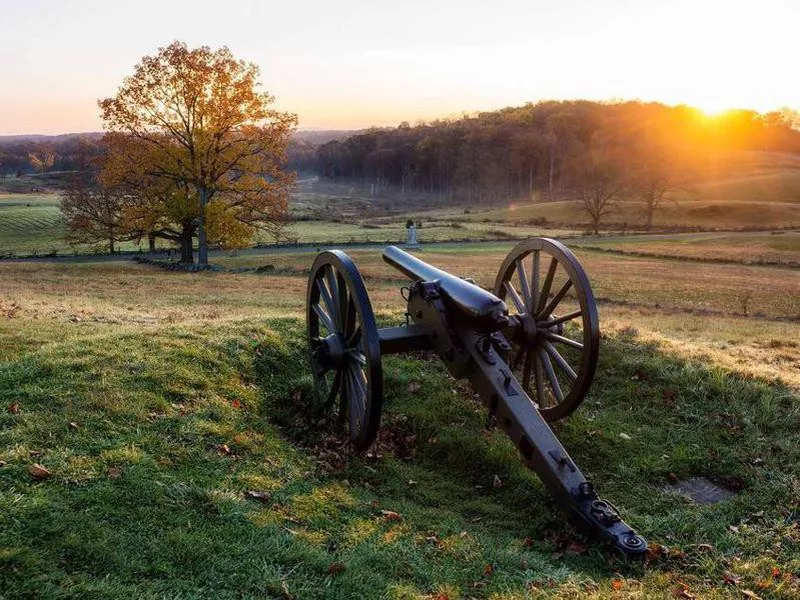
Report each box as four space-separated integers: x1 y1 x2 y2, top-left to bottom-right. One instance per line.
572 231 800 265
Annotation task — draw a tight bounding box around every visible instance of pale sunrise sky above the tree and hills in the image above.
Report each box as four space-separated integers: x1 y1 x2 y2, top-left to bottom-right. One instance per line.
0 0 800 134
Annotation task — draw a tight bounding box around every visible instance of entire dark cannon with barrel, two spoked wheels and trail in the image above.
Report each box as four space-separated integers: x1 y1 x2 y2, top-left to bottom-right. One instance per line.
307 238 647 556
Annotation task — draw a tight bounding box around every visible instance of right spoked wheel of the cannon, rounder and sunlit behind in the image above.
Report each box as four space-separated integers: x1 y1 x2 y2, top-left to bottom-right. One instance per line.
494 238 600 421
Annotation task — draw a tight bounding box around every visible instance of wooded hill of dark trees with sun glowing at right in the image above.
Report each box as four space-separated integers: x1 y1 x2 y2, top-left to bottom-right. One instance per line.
317 100 800 229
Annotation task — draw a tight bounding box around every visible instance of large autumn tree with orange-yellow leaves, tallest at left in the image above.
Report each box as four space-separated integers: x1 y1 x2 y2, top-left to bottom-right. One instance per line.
99 42 297 266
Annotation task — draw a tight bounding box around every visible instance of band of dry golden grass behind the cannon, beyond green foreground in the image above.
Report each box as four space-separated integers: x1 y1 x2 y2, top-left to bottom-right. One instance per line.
0 248 800 387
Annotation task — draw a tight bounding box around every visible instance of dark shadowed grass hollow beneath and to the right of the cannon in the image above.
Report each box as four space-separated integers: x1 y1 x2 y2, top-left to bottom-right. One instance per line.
255 318 800 596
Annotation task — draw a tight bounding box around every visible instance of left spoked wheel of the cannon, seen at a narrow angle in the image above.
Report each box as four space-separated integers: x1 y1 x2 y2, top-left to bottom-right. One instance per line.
306 250 383 450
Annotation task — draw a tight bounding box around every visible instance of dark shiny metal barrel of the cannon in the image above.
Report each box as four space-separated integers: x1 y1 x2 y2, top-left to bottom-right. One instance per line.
383 246 508 331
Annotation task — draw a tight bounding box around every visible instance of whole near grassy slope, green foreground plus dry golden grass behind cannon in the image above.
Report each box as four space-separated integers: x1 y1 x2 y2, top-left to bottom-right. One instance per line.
0 244 800 600
